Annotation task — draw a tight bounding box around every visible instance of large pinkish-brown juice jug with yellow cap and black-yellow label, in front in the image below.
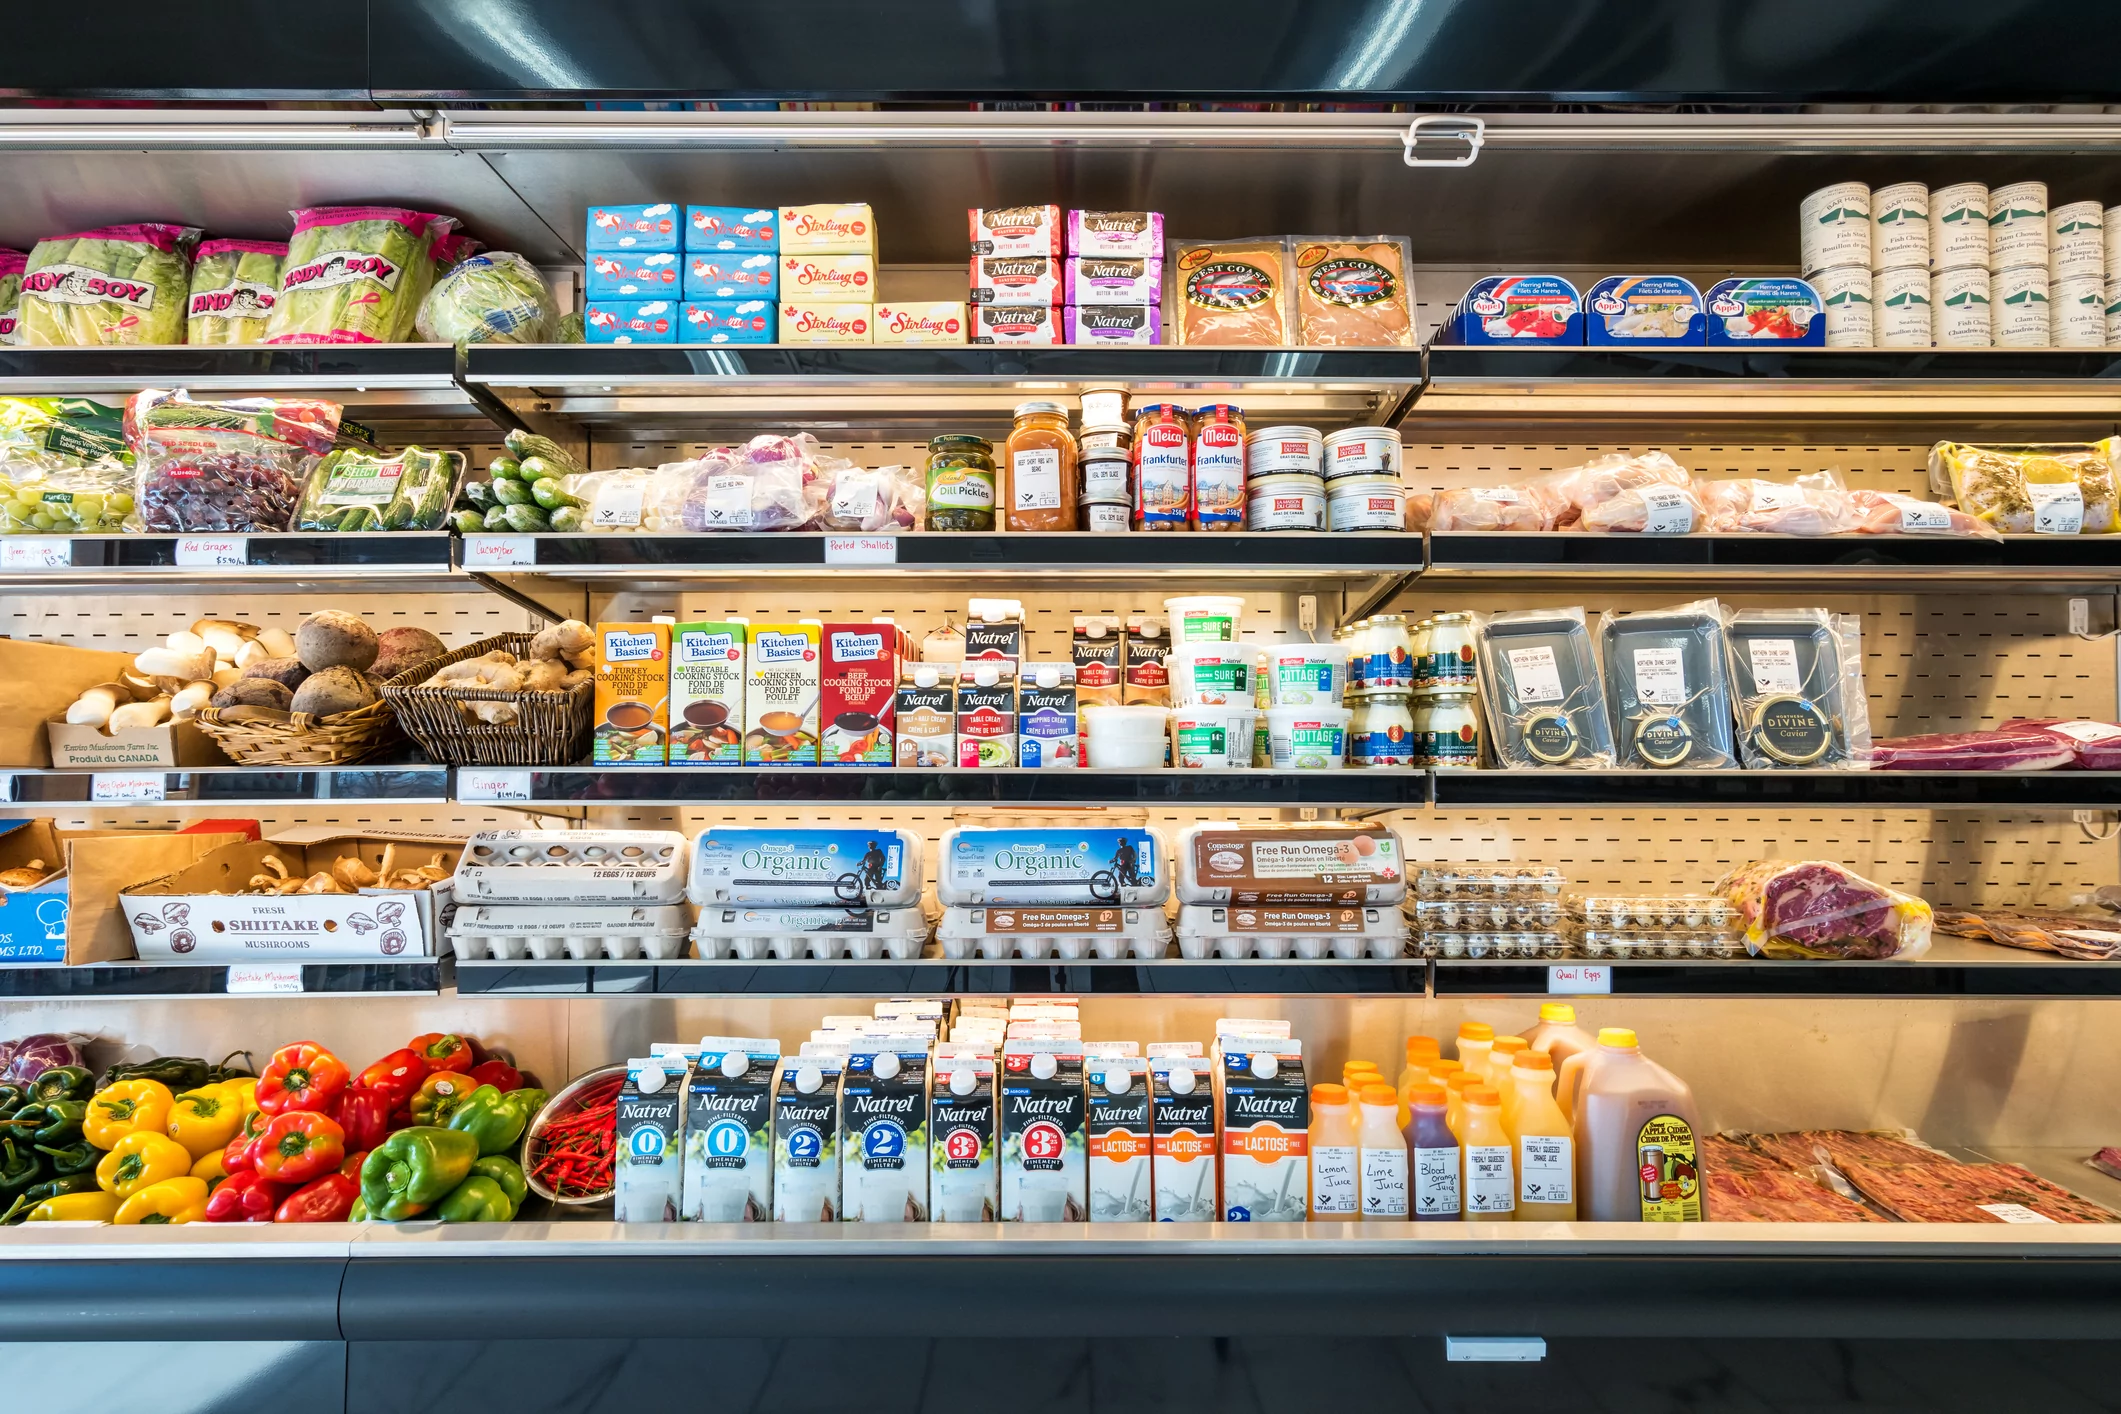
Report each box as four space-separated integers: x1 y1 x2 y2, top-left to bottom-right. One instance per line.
1574 1028 1701 1223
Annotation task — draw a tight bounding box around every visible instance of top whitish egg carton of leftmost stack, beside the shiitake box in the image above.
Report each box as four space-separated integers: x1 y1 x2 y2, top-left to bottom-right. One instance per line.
456 829 685 903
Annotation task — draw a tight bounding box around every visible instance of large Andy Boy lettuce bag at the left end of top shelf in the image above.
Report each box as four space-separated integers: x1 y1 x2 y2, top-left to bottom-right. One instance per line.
21 225 199 348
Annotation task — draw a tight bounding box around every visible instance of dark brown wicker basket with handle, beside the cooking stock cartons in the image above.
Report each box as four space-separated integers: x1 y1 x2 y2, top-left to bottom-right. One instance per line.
384 634 596 765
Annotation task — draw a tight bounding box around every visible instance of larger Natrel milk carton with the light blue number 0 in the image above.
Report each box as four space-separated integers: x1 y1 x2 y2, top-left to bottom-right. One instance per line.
679 1037 781 1223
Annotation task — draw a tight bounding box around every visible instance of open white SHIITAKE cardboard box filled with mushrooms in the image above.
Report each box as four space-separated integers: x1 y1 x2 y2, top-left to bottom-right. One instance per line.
119 829 462 962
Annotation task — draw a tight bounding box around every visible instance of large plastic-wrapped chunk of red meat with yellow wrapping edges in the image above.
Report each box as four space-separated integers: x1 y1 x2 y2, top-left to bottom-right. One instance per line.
1716 859 1930 960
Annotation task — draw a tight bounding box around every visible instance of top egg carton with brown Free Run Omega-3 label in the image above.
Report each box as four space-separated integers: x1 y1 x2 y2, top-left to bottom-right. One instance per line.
1177 823 1406 905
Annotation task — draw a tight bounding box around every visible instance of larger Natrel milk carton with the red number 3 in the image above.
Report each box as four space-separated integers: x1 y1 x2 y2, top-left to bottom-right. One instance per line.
1001 1039 1085 1223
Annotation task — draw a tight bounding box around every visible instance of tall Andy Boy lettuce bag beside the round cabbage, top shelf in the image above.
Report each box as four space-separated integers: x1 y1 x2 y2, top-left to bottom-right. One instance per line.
265 206 456 343
